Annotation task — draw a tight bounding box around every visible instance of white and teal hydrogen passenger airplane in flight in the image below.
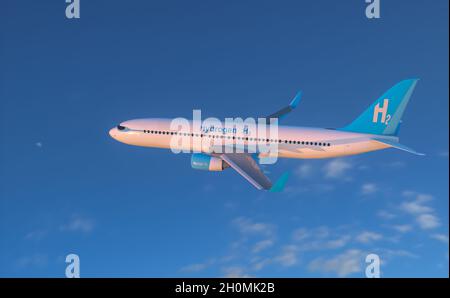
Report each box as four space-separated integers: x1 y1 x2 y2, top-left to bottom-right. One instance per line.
109 79 424 192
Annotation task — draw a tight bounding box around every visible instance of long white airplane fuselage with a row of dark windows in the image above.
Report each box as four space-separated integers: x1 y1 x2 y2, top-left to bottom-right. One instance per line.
109 118 397 158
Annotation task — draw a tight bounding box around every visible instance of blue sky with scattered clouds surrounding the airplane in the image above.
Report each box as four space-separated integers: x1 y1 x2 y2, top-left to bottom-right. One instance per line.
0 0 449 277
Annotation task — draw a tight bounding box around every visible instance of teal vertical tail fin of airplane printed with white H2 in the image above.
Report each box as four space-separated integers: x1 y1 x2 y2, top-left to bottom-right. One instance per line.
341 79 418 136
